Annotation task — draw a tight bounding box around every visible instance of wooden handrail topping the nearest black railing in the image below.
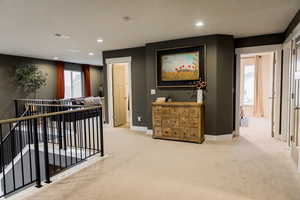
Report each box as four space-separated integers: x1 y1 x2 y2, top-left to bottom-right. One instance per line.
0 106 102 124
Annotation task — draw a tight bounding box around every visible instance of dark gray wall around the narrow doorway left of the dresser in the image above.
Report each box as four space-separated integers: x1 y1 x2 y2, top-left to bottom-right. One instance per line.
103 47 148 126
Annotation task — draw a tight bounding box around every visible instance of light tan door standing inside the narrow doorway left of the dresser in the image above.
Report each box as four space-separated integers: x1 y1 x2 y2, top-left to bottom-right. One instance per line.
112 64 128 127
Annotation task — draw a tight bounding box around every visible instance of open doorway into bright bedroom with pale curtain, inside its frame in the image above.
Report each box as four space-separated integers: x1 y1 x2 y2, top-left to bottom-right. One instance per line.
240 52 275 138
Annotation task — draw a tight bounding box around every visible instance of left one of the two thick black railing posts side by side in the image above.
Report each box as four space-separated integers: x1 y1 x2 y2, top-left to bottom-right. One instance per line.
33 119 42 188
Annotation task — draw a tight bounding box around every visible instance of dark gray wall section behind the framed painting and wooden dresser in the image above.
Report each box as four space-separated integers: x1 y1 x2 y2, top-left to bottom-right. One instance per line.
146 35 234 135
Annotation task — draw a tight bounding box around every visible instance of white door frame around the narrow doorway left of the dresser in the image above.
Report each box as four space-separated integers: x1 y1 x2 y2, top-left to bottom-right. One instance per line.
105 57 133 129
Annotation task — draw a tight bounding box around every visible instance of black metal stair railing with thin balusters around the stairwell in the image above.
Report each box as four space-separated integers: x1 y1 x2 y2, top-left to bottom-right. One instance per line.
0 104 104 197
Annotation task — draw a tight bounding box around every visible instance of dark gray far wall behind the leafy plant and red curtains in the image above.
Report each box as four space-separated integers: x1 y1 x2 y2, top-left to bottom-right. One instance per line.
0 54 103 119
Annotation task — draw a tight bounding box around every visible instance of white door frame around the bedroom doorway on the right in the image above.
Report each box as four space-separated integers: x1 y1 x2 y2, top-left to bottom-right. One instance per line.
234 44 282 139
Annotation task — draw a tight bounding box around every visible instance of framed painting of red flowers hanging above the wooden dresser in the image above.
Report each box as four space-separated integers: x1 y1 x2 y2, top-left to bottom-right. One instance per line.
157 46 205 87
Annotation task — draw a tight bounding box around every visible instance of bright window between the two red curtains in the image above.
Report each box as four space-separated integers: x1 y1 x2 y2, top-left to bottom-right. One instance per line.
64 70 83 98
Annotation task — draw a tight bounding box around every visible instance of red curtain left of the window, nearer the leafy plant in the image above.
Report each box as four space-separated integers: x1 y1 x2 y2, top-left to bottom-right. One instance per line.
56 61 65 99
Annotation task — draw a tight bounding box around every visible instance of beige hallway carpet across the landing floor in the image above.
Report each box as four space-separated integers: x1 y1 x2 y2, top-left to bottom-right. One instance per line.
22 125 300 200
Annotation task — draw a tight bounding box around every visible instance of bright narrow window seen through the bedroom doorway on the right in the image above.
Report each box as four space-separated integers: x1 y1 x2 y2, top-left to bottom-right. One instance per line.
243 64 255 105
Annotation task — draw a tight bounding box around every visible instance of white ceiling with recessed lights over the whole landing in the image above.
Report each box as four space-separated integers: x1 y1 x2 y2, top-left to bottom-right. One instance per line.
0 0 300 65
